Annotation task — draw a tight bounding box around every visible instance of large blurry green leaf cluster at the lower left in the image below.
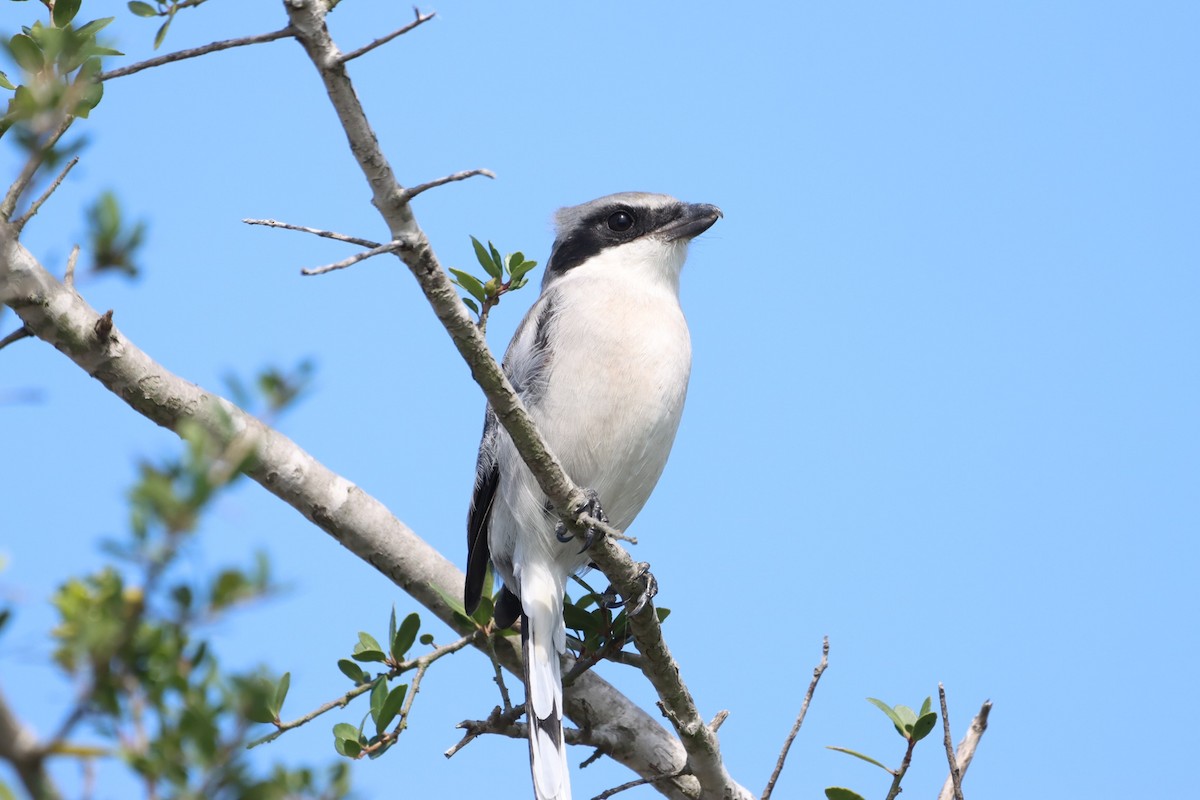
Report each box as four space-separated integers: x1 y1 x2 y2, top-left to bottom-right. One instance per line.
0 367 349 800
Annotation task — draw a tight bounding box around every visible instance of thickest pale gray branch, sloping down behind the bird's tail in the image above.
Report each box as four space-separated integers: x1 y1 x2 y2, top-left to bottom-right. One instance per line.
0 223 698 800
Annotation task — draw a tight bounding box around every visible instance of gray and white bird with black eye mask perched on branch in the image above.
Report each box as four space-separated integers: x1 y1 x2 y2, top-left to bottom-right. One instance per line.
463 192 724 800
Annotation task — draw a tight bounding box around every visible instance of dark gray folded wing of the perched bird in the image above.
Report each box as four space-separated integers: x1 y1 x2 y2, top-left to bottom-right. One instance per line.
463 291 556 622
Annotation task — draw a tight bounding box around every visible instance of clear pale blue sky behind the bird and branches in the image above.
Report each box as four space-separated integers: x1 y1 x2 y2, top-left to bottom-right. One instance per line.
0 0 1200 800
